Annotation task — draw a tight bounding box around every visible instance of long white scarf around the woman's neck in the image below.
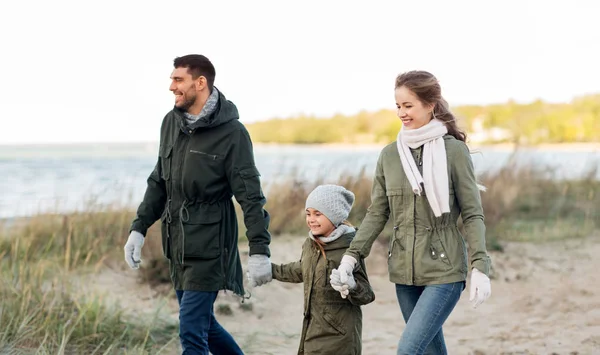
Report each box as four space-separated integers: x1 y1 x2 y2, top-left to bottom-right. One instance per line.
396 119 450 217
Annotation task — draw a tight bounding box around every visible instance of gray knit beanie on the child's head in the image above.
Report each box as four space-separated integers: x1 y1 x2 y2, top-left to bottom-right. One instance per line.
305 185 354 227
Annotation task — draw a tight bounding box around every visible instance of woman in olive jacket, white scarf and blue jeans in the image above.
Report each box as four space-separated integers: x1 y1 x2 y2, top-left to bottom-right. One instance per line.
331 71 491 355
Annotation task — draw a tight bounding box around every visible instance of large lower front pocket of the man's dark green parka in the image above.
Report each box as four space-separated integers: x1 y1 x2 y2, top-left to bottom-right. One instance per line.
182 208 221 259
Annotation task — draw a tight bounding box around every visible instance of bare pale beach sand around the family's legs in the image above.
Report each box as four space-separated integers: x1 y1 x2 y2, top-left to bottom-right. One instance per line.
83 232 600 355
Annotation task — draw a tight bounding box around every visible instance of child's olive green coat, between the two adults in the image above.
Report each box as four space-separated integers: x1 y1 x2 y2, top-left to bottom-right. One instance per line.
272 232 375 355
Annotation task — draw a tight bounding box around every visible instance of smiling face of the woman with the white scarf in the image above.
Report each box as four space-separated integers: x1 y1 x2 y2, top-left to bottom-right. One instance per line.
396 86 433 129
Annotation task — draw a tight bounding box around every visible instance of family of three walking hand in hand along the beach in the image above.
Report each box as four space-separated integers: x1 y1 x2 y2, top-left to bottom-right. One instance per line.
125 55 491 355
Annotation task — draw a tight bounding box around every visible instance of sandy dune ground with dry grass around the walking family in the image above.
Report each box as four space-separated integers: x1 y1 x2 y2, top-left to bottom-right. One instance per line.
0 166 600 355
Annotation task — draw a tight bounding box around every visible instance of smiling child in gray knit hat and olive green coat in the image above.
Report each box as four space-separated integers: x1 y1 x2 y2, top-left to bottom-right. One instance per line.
272 185 375 355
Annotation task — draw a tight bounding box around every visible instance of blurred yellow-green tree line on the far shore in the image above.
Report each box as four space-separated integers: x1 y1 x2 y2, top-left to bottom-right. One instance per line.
247 94 600 144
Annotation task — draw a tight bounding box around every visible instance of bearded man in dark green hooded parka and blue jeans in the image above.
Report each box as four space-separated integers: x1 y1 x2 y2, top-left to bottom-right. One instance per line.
125 54 271 354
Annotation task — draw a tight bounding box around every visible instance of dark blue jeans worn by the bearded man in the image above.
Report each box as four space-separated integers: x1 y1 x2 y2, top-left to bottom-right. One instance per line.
175 291 244 355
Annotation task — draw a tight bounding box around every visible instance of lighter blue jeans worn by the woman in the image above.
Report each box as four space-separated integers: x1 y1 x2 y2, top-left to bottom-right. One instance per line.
396 281 465 355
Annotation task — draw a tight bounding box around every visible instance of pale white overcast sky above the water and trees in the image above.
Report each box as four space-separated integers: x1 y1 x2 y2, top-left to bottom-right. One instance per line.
0 0 600 144
